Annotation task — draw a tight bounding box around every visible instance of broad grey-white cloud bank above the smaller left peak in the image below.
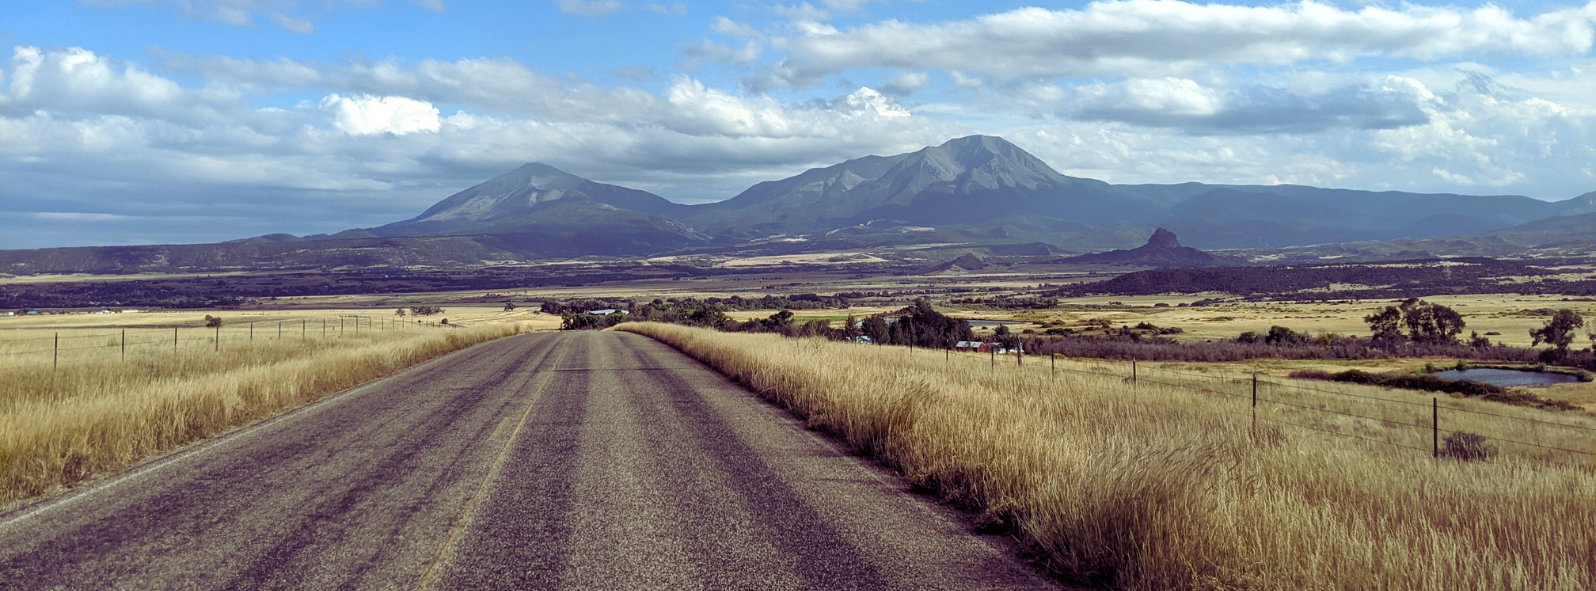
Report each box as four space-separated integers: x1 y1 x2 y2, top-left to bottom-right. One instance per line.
0 46 944 248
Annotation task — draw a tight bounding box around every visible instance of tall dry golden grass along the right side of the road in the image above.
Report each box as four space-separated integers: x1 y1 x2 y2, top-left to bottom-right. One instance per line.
621 323 1596 591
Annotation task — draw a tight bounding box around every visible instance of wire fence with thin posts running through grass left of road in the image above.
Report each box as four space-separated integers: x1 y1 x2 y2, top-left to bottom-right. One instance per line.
0 315 448 369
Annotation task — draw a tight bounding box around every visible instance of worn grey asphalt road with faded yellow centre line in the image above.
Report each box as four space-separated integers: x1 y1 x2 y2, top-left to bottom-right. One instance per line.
0 332 1055 589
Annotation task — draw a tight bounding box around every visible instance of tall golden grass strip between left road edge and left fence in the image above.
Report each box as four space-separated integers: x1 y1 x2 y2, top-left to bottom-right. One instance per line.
0 324 522 510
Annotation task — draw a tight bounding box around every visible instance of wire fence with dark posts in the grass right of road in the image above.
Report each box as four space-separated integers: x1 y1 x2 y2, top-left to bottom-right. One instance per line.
966 346 1596 465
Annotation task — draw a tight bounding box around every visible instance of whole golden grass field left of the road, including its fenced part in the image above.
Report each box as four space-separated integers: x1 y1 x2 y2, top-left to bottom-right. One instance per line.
0 310 528 510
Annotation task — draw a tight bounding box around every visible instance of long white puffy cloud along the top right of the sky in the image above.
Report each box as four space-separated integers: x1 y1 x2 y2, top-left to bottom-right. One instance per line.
772 0 1596 78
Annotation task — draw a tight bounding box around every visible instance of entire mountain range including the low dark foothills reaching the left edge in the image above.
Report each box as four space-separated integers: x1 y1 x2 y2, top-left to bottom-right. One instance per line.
0 136 1596 273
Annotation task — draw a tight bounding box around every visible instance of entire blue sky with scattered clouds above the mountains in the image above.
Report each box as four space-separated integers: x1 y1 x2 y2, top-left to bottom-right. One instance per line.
0 0 1596 249
